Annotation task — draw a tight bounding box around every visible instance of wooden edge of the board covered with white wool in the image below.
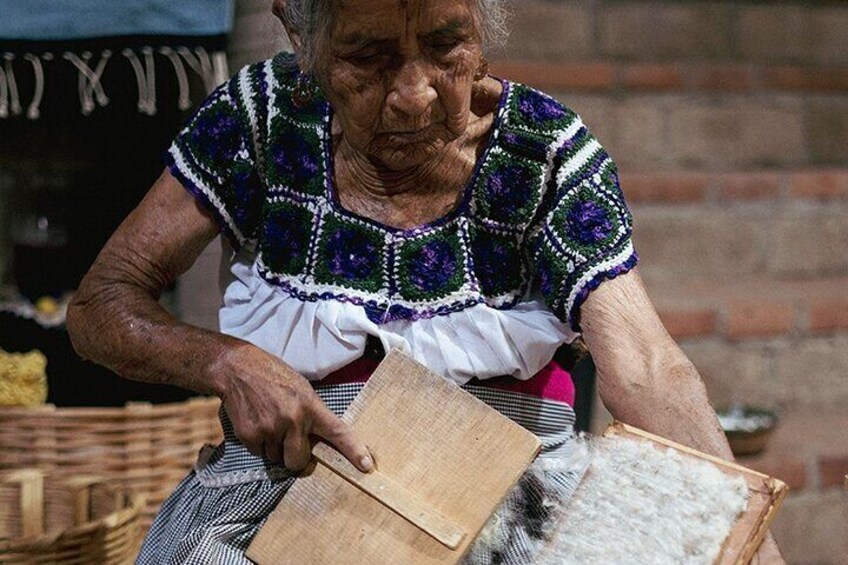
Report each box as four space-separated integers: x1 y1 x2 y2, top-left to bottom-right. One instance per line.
604 422 788 565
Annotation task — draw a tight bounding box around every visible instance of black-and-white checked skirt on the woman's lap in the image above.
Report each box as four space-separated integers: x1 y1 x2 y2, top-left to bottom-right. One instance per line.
136 383 583 565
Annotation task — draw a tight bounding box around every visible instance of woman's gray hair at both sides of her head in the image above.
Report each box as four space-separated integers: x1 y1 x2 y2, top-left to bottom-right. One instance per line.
274 0 509 71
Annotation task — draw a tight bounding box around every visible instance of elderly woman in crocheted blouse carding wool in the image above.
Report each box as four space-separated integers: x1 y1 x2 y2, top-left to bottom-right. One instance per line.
68 0 779 564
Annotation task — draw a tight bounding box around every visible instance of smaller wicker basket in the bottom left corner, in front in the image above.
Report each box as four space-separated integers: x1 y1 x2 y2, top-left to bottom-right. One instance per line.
0 469 144 565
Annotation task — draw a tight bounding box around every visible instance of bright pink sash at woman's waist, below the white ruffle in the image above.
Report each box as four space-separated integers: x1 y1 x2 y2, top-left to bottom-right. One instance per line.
313 357 574 406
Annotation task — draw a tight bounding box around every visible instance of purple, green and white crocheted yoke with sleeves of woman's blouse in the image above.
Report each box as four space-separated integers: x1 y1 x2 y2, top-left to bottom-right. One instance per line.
169 56 636 329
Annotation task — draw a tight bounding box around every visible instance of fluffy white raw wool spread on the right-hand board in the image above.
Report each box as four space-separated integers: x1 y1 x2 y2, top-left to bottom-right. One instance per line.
537 437 748 565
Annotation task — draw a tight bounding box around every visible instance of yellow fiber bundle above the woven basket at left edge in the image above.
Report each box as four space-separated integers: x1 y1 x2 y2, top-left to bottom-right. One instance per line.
0 349 47 406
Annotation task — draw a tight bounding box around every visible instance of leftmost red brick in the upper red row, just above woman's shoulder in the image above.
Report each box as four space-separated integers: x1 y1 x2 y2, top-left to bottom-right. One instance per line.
491 60 615 90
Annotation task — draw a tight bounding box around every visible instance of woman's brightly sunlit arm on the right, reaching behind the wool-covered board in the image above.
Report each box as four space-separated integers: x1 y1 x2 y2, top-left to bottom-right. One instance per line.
580 269 783 563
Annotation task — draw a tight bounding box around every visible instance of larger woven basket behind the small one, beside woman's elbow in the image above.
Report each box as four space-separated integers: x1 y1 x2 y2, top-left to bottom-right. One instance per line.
0 398 222 529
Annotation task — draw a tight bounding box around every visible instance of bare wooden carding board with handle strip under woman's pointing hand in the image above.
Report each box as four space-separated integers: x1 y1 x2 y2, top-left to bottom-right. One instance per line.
247 351 541 565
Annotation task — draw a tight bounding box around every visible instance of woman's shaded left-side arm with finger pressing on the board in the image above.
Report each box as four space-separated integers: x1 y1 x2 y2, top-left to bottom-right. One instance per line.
67 171 370 471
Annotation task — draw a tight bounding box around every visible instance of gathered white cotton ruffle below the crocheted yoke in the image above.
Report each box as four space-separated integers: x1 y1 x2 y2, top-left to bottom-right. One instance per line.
219 240 575 384
